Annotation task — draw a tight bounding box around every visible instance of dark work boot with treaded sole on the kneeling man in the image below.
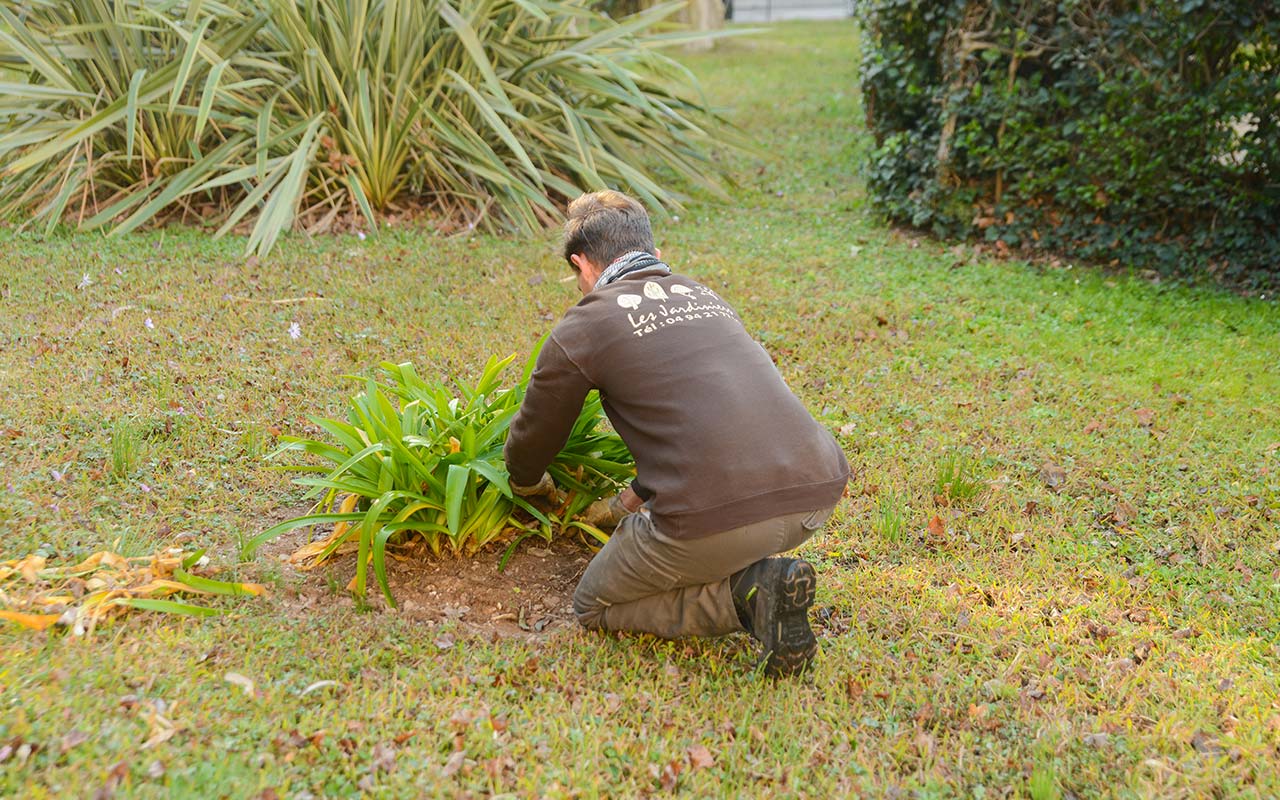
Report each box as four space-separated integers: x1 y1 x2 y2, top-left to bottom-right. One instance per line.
730 558 818 677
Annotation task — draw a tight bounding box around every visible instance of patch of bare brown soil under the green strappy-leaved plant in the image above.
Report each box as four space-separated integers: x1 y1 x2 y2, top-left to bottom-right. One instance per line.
262 531 593 637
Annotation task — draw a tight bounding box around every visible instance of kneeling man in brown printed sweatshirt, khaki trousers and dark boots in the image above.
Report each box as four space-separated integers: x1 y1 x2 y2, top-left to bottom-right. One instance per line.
504 191 849 676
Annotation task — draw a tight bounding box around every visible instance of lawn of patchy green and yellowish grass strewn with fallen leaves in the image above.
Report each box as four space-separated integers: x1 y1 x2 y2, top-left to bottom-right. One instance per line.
0 23 1280 797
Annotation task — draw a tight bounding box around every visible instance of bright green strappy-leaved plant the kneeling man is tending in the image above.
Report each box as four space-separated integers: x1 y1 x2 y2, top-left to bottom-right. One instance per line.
246 356 635 604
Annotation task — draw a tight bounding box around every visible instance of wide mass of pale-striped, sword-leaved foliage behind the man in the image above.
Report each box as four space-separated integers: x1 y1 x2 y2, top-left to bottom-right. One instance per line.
0 0 741 252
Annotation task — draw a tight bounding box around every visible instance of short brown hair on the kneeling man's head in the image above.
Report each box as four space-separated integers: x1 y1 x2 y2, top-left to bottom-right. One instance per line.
564 189 653 270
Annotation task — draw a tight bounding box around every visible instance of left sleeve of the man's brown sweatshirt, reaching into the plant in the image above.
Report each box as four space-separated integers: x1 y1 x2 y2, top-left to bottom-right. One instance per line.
502 334 593 486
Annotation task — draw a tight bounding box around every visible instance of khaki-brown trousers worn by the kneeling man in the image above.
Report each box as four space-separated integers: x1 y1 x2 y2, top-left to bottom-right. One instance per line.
573 508 832 639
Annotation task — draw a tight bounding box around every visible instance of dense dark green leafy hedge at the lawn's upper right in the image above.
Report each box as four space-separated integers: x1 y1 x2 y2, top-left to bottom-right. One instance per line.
859 0 1280 284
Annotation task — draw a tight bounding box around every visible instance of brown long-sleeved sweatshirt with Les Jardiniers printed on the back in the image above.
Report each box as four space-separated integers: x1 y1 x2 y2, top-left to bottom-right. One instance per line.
503 270 849 539
